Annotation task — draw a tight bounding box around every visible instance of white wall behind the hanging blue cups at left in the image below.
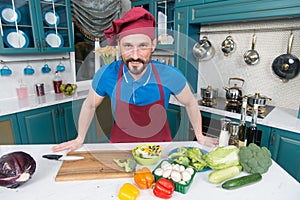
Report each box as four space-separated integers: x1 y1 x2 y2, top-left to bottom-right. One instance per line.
0 53 74 100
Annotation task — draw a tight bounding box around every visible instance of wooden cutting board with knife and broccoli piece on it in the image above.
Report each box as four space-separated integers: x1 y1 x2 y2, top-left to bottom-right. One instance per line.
55 150 134 182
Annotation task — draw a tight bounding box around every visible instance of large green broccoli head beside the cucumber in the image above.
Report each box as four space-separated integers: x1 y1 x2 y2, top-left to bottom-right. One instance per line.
239 143 272 174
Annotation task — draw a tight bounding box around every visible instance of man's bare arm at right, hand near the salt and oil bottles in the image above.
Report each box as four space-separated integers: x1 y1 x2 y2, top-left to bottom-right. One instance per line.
176 83 218 146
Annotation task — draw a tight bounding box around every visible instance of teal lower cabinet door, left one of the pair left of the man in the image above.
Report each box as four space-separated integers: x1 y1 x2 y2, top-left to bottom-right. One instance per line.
17 106 62 144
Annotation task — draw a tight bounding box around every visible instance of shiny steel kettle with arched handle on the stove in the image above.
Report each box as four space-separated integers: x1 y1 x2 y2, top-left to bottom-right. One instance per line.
223 78 244 102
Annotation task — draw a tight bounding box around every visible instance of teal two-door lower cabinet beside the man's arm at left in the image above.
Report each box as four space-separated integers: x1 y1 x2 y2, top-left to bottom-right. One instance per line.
17 100 95 144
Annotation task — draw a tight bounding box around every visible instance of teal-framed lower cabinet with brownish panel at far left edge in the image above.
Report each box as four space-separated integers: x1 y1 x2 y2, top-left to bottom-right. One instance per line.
0 114 21 145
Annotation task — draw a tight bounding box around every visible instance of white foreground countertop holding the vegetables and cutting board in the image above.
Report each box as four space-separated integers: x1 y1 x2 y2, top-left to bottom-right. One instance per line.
0 142 300 200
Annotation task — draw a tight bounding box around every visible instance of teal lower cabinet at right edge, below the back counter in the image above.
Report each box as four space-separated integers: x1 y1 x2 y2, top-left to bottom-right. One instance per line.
269 128 300 182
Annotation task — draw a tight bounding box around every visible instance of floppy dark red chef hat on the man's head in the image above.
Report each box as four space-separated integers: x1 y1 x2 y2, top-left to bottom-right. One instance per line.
104 7 156 46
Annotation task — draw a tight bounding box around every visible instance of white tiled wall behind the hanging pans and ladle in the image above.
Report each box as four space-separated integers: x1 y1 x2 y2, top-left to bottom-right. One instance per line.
198 18 300 110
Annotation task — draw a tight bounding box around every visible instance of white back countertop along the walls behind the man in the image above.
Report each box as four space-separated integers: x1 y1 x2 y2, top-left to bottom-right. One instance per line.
0 90 300 133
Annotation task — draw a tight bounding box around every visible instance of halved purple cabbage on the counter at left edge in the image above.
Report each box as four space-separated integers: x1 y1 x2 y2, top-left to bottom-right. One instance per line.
0 151 36 188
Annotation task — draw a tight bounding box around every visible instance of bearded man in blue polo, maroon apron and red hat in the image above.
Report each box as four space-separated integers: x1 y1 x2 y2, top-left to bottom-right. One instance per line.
53 7 218 152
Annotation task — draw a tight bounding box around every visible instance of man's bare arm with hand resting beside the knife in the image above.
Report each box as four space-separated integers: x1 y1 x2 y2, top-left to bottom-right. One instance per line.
52 88 104 152
